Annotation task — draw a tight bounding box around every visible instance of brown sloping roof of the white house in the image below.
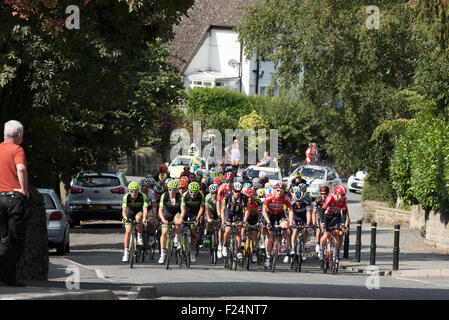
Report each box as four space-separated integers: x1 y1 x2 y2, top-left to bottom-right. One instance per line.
170 0 261 73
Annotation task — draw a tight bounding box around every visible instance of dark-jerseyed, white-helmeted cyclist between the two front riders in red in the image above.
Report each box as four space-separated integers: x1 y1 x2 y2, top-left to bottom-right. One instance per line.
289 191 311 260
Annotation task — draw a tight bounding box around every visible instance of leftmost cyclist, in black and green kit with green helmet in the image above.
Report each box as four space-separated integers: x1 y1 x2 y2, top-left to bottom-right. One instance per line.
122 182 148 262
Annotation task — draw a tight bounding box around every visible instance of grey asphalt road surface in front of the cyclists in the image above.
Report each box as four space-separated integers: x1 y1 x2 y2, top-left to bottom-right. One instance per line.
50 189 449 300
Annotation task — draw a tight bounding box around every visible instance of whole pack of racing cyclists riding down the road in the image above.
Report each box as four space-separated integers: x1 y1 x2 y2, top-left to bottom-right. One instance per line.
122 165 350 268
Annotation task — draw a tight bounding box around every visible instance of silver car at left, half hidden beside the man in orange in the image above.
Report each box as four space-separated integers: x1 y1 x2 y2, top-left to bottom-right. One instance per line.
37 188 70 255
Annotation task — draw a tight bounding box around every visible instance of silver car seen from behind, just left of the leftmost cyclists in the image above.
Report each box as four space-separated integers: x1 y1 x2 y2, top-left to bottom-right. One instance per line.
66 171 128 226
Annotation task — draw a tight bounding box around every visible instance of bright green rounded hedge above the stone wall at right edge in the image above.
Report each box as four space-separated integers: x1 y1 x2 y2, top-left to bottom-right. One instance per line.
390 113 449 212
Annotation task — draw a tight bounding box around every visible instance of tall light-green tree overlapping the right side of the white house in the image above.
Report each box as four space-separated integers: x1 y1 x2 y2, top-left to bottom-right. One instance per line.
238 0 419 171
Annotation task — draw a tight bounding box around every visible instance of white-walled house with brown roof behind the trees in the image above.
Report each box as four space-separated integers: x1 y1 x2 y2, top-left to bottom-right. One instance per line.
171 0 276 95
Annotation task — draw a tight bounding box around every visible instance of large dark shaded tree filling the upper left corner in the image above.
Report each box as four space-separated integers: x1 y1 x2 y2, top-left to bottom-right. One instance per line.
0 0 193 186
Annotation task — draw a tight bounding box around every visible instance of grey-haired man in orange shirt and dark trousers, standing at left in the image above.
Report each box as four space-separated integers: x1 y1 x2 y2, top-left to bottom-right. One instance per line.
0 120 30 287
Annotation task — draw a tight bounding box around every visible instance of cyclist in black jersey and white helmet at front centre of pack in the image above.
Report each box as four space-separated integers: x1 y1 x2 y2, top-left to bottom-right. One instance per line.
221 182 248 259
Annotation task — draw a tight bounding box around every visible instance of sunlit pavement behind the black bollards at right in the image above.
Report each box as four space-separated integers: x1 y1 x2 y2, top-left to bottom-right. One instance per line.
340 222 449 277
